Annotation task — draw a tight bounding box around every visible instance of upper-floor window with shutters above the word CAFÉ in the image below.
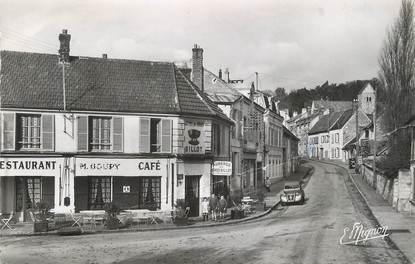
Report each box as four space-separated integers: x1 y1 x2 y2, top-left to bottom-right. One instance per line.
139 117 172 153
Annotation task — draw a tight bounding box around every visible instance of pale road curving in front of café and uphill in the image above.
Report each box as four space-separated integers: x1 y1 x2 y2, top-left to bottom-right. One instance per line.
0 162 406 264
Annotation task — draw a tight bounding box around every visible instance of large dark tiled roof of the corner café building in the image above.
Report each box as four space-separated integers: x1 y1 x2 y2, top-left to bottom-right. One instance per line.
0 51 229 121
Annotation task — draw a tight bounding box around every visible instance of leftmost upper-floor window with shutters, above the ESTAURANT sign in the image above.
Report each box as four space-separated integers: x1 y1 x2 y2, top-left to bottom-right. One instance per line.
0 113 55 151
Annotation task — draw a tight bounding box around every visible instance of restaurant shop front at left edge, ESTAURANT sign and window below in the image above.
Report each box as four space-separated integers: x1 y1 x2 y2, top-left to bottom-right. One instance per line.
0 157 64 222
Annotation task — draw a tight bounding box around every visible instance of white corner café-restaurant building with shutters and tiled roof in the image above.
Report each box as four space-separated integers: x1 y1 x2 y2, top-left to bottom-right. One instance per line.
0 30 232 221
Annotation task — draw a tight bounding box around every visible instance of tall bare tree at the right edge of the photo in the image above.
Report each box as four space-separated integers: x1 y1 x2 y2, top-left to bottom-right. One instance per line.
379 0 415 176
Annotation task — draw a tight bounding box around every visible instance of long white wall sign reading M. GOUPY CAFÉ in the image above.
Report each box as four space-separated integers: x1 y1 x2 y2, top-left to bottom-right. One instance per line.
75 158 167 176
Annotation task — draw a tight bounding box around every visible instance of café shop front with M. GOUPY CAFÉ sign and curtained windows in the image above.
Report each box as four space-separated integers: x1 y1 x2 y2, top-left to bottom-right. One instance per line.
75 158 174 212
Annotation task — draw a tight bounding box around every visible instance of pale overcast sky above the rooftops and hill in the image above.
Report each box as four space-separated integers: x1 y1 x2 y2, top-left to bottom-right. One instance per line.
0 0 401 91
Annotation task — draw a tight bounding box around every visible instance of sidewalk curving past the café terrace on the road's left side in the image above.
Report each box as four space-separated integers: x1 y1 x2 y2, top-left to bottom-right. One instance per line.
0 164 311 237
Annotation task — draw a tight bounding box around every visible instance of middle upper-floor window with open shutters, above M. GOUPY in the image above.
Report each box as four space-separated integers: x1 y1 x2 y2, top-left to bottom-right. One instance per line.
78 116 123 152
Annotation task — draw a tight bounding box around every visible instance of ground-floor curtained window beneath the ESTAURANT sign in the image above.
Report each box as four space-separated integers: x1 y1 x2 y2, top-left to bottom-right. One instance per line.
16 177 41 212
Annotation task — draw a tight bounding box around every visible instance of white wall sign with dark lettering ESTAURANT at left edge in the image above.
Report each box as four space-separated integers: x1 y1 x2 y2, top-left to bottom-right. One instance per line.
0 158 63 176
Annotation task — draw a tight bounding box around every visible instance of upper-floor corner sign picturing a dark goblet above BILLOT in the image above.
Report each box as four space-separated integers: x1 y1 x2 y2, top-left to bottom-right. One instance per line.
183 120 206 154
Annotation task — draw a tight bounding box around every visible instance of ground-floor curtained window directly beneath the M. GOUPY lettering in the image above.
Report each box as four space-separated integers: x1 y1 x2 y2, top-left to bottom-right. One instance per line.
88 177 111 209
